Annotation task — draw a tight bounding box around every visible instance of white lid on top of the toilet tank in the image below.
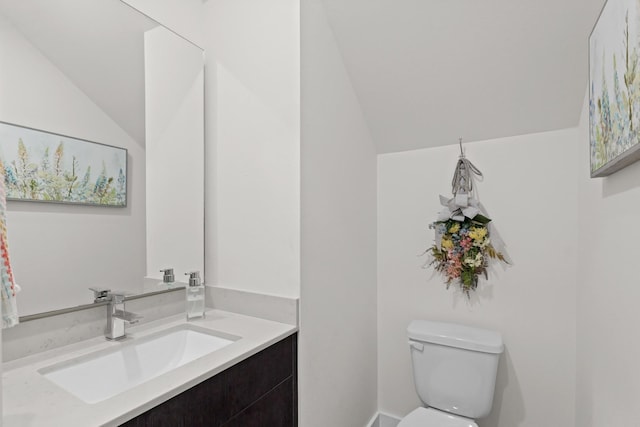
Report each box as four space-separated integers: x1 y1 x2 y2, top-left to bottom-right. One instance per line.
407 320 504 354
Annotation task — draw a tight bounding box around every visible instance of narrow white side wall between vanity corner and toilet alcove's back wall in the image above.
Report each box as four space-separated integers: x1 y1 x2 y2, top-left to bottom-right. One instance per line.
299 0 377 427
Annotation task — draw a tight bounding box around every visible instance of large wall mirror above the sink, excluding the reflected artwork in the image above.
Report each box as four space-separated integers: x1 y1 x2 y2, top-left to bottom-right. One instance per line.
0 0 204 316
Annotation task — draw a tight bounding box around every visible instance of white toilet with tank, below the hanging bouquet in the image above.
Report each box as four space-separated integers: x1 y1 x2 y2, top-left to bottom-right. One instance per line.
398 320 504 427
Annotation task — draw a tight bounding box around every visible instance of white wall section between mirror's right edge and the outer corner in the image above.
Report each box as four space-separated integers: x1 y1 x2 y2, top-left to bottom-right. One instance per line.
204 0 300 297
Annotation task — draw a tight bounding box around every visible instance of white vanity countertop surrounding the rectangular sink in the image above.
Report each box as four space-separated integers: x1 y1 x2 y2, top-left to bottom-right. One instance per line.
2 310 297 427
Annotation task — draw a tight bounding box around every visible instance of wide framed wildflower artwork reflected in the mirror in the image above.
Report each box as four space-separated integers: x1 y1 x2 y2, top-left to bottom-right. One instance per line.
0 122 127 207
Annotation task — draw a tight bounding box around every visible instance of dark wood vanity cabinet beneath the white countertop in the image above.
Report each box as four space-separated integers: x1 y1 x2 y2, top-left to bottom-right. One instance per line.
122 334 298 427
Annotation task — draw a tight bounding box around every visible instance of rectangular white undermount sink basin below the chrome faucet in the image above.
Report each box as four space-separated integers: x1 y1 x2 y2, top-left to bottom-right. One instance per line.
39 325 238 403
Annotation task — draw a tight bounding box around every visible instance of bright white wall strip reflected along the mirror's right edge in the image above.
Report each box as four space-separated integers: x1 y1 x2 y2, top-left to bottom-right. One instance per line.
145 27 206 289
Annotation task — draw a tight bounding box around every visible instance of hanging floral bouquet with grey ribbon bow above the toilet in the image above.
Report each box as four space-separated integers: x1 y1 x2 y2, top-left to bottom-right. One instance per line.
425 140 512 297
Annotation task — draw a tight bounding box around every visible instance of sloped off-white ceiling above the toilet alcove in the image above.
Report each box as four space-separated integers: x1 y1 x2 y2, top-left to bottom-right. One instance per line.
324 0 604 153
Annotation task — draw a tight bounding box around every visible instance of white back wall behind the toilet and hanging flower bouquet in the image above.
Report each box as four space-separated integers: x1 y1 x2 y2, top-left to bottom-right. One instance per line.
378 129 576 427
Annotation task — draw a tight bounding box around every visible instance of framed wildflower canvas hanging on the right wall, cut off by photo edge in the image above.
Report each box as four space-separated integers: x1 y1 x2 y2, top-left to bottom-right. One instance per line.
589 0 640 178
